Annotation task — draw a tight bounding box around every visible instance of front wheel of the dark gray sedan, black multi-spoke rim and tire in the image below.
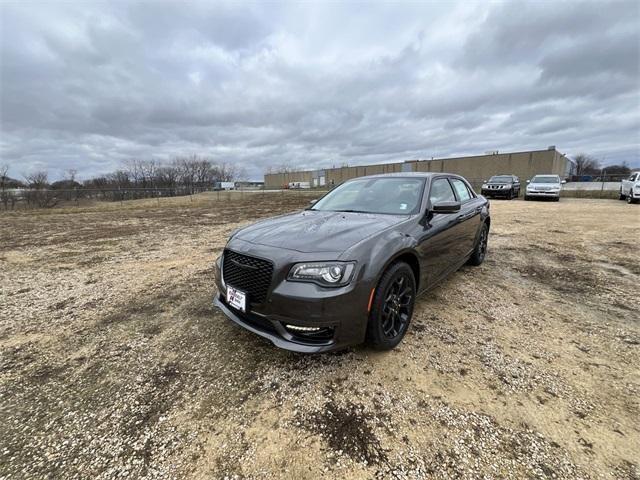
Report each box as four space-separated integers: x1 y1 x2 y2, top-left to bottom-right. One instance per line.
367 262 416 350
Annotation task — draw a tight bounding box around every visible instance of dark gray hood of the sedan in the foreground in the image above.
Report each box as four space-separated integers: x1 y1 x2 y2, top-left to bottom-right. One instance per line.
233 210 408 253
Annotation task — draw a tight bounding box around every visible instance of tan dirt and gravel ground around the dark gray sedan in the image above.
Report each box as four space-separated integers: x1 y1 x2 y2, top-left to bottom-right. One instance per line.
0 193 640 479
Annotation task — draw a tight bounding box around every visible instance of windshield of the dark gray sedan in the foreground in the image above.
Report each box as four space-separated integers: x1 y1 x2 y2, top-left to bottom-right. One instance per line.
311 177 424 215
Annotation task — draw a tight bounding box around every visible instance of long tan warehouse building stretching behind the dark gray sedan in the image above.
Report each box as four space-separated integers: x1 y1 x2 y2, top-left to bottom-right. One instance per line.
264 149 569 188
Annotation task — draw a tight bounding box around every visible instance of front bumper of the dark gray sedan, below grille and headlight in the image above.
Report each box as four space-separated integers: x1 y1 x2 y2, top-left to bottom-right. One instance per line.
213 241 370 353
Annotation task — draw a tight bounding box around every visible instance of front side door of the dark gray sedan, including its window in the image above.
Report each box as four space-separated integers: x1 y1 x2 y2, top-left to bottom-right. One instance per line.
416 176 465 288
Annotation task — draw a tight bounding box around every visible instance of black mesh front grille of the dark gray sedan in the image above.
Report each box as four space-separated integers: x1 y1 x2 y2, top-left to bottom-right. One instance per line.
222 250 273 303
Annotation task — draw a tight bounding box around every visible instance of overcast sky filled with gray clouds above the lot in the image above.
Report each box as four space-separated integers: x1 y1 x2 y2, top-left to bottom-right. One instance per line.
0 1 640 179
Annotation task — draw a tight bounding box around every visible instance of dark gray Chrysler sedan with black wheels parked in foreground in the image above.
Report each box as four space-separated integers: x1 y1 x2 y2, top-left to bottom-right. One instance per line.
214 173 491 352
